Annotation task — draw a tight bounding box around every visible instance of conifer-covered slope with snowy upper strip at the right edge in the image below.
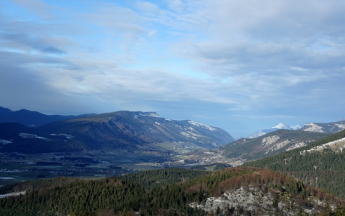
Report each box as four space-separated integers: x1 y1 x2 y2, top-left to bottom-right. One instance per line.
245 130 345 198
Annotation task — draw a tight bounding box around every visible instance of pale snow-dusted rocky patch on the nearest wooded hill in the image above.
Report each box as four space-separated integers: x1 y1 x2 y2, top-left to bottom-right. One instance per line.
190 185 326 216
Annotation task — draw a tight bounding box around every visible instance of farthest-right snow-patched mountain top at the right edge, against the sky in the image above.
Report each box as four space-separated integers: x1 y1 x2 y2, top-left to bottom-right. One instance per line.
300 119 345 133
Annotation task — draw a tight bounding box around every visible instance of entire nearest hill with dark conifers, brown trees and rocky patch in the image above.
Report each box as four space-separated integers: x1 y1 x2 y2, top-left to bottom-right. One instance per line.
0 168 344 216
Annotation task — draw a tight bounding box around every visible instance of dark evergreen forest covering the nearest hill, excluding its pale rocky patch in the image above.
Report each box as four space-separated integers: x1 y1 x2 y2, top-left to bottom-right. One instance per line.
0 168 344 216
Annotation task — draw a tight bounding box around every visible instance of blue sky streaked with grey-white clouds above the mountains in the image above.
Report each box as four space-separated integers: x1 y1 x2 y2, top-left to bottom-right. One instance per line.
0 0 345 138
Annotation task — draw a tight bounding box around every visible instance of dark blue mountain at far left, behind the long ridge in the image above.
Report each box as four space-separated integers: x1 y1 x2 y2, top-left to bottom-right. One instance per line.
0 107 92 127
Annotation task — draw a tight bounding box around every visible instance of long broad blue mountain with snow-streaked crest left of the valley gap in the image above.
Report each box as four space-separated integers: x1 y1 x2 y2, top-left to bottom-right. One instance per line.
0 111 234 153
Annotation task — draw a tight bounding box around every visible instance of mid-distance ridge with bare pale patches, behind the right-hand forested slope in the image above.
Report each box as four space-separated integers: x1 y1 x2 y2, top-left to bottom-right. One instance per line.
219 129 328 160
